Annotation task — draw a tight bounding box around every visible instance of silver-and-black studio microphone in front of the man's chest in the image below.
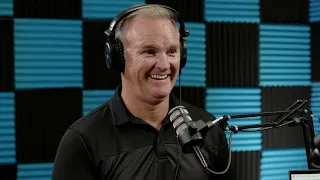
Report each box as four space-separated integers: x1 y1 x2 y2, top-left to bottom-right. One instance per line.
168 106 230 154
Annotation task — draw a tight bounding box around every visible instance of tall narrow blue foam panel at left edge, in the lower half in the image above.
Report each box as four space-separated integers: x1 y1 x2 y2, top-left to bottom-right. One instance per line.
0 92 16 165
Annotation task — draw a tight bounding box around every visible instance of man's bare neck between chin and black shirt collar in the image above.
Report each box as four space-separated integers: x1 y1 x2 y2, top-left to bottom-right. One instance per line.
121 84 169 131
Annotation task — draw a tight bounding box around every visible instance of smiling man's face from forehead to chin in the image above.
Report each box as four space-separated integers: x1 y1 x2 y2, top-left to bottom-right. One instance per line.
124 17 180 103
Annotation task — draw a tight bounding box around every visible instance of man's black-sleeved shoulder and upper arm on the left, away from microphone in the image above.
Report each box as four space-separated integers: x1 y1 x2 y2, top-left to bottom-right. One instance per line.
53 101 112 179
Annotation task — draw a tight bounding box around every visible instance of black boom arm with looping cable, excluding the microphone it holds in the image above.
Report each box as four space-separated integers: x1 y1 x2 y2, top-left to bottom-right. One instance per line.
188 100 315 174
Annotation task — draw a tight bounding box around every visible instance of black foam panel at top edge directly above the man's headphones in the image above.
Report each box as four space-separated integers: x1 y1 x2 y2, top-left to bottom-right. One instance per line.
146 0 204 22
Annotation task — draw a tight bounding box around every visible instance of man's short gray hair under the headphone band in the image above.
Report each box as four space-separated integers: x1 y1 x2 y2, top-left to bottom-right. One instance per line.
115 5 179 43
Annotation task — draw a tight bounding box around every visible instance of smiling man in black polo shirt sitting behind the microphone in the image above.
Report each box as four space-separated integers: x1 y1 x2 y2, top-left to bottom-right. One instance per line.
52 5 229 180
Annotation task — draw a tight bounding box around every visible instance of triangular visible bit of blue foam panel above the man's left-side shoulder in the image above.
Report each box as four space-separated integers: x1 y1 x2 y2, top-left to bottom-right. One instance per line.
82 90 115 115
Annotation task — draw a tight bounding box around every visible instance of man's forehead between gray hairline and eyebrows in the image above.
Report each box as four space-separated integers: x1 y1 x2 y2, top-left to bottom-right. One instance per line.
125 17 179 43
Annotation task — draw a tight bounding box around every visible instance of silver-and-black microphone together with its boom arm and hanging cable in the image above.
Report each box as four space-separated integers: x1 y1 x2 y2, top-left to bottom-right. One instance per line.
168 100 320 174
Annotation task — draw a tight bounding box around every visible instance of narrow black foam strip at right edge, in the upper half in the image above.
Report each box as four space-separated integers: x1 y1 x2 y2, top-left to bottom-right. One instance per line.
311 22 320 81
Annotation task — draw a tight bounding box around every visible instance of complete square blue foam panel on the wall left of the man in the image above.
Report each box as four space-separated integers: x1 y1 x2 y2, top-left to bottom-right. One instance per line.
14 19 83 89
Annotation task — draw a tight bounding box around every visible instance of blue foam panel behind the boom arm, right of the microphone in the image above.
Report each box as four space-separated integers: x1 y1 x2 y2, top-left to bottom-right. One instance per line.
206 88 262 151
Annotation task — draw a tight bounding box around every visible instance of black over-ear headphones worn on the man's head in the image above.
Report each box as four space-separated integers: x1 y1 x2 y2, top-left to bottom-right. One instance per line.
104 4 189 73
